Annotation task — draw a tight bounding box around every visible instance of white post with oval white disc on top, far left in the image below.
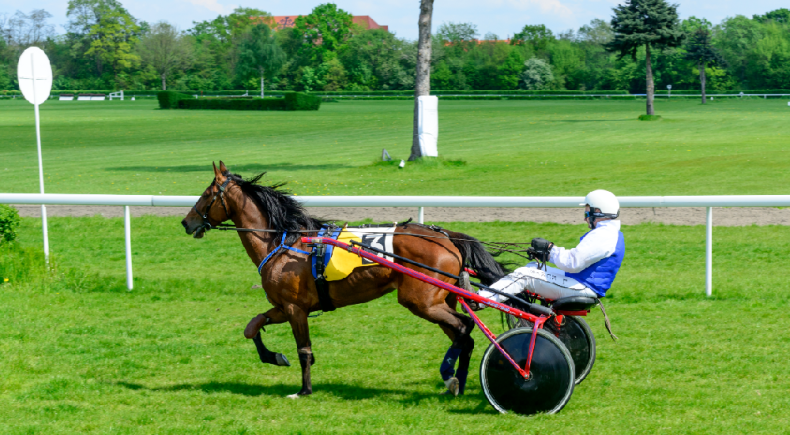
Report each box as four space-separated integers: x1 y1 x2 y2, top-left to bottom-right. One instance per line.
17 47 52 264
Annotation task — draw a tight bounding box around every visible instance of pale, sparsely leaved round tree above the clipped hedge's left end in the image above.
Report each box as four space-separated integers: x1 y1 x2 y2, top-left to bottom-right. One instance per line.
137 21 193 91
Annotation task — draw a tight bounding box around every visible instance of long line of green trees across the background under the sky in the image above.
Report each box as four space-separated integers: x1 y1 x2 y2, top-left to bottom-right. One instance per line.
0 0 790 93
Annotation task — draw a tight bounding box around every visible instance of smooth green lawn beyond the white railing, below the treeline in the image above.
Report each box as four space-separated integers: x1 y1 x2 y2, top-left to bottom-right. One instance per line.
0 99 790 196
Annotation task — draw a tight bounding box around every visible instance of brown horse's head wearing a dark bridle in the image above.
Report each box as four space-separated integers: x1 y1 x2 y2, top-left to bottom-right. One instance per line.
181 160 232 239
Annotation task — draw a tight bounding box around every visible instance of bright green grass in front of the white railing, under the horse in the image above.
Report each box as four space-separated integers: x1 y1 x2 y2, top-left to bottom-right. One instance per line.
0 216 790 434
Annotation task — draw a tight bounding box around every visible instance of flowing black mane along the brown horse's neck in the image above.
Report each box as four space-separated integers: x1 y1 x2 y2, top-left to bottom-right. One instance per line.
225 172 326 244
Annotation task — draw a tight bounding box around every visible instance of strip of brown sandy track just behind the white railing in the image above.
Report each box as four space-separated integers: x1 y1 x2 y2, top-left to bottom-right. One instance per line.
14 205 790 226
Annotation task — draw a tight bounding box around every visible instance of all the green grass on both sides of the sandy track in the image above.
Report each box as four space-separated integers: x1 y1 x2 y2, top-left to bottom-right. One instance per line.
0 100 790 434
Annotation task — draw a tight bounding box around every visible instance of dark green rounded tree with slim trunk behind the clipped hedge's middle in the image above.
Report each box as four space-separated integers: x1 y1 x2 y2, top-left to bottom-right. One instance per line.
238 24 285 98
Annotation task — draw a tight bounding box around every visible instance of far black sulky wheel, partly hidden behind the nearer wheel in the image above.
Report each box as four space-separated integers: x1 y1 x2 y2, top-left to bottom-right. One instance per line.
507 315 595 385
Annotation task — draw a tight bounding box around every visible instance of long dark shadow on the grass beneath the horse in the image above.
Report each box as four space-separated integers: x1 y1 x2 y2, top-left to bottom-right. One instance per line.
114 381 482 408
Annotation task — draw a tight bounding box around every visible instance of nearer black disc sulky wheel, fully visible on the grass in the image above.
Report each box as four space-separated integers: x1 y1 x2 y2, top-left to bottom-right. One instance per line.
480 328 575 414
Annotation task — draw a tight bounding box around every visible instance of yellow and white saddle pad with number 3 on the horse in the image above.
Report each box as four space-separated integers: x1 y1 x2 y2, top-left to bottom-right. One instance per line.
324 225 395 281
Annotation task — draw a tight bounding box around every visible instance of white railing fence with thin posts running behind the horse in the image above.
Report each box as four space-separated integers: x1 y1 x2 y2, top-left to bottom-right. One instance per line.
0 193 790 296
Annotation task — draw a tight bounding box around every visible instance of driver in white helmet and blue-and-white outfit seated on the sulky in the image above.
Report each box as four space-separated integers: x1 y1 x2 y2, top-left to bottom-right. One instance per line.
478 190 625 309
